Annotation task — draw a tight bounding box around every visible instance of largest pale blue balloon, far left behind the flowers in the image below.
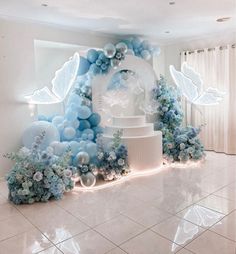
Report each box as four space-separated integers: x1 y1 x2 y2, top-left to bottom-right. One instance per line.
22 121 60 150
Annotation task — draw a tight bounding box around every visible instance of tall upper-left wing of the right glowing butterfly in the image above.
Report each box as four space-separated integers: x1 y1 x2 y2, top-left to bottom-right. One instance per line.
170 65 199 103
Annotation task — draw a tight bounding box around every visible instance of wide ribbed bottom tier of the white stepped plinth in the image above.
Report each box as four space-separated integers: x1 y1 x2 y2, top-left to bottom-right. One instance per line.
103 131 163 171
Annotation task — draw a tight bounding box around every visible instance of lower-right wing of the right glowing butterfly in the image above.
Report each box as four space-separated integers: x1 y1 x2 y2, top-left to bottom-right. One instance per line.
194 87 225 105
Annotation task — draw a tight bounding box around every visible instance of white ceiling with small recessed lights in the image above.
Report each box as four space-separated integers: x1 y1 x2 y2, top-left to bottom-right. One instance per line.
0 0 236 44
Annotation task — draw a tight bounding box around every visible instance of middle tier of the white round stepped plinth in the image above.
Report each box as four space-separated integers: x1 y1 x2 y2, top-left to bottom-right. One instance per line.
104 123 154 137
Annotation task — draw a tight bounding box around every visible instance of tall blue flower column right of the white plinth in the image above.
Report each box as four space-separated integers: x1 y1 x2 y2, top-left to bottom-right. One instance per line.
152 77 204 162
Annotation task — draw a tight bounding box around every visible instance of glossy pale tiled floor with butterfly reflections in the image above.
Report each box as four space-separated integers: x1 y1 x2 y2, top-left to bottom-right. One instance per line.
0 152 236 254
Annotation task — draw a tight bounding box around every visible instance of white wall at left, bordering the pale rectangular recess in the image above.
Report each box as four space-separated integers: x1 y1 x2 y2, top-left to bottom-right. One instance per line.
0 19 115 177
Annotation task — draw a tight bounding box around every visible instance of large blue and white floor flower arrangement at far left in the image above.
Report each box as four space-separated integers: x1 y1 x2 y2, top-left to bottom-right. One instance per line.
5 132 75 204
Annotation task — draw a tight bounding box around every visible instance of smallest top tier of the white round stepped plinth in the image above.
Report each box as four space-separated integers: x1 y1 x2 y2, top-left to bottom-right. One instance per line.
112 115 146 127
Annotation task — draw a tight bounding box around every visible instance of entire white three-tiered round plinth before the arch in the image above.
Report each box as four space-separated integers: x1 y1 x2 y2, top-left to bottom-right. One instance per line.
103 116 162 170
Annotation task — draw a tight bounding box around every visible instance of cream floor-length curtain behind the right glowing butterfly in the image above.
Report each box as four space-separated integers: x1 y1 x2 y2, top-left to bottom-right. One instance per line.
181 45 236 154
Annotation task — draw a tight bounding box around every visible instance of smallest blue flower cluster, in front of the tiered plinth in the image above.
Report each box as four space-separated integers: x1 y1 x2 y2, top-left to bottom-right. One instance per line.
97 130 129 181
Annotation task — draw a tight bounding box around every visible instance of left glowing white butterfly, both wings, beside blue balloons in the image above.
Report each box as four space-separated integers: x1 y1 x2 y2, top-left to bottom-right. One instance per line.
25 53 80 104
